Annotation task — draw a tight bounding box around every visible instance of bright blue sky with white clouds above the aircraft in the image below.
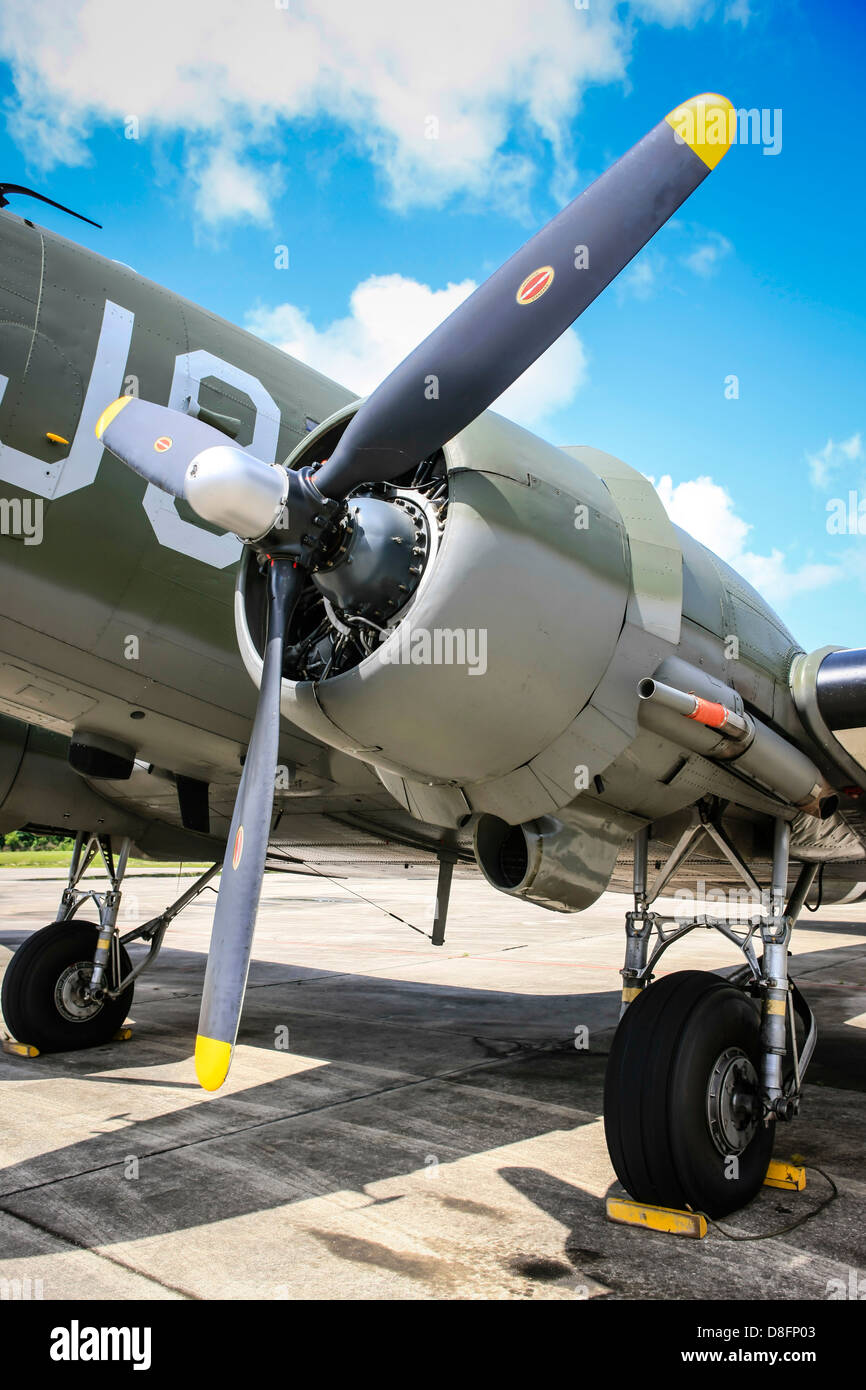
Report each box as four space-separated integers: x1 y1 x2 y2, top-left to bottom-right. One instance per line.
0 0 866 648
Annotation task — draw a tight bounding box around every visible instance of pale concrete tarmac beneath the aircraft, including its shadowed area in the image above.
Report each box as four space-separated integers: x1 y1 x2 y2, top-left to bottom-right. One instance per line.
0 869 866 1301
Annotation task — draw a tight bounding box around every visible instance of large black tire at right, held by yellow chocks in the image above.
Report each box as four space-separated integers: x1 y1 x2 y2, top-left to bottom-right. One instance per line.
605 970 776 1216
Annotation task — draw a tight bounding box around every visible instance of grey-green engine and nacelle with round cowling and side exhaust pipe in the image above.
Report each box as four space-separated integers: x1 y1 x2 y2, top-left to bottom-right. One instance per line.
235 406 853 910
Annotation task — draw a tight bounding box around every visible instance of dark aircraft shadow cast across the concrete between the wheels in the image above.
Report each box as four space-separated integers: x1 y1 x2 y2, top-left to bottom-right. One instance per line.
0 924 866 1255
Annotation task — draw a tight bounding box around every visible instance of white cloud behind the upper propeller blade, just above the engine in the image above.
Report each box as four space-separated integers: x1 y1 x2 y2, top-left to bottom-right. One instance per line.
245 275 587 425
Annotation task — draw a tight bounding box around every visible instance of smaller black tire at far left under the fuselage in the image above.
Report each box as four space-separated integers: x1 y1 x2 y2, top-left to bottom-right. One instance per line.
1 919 135 1052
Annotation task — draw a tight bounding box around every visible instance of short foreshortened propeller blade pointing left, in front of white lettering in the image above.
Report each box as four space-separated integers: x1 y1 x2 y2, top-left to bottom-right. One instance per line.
96 396 227 498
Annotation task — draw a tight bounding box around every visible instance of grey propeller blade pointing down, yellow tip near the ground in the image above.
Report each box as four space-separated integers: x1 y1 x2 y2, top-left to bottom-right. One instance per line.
196 556 304 1091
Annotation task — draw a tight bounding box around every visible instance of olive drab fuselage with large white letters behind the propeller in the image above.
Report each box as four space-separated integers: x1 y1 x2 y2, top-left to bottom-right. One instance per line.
0 213 861 895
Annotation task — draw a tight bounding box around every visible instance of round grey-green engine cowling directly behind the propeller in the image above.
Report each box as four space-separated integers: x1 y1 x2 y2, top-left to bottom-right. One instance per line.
235 406 636 824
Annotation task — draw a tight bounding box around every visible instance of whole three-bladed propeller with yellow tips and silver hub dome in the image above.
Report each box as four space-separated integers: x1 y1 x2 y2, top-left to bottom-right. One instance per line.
96 93 733 1090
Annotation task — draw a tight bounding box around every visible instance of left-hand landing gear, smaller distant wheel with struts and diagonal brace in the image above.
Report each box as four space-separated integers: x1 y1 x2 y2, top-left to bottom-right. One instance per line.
1 834 220 1052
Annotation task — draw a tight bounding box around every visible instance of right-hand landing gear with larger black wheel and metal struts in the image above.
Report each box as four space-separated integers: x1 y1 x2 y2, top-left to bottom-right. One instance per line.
605 808 817 1216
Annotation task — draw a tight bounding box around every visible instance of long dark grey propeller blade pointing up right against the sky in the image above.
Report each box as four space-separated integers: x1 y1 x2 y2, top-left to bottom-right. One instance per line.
316 92 733 498
